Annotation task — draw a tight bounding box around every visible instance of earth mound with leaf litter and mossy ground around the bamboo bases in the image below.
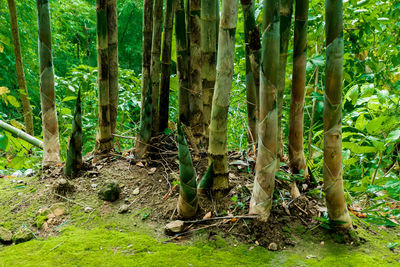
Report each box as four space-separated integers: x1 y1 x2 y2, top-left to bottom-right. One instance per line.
0 144 400 266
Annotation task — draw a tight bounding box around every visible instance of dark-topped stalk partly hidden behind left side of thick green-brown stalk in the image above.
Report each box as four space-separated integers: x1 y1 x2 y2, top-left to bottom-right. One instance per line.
241 0 261 144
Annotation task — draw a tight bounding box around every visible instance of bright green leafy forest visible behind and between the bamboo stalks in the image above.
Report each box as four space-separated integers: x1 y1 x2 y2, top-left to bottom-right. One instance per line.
0 0 400 226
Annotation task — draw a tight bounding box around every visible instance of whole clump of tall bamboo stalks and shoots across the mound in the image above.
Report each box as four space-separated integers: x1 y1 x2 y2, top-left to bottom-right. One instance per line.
4 0 352 229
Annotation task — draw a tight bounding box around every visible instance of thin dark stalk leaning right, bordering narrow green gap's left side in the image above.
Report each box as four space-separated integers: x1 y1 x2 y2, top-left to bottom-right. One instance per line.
158 0 176 132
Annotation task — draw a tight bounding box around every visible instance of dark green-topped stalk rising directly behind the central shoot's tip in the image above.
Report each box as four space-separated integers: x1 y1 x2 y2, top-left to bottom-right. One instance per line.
175 0 190 125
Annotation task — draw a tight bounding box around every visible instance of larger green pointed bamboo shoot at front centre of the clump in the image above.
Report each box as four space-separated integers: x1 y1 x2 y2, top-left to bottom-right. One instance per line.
177 125 198 218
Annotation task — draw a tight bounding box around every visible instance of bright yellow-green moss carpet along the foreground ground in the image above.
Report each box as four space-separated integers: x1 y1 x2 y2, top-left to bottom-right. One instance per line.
0 171 400 266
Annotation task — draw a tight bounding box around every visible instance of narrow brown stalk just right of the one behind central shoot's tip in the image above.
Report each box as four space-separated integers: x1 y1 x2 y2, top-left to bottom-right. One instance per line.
189 0 204 146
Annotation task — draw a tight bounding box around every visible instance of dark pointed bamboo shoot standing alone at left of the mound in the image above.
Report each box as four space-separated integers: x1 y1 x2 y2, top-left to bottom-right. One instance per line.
64 89 82 177
